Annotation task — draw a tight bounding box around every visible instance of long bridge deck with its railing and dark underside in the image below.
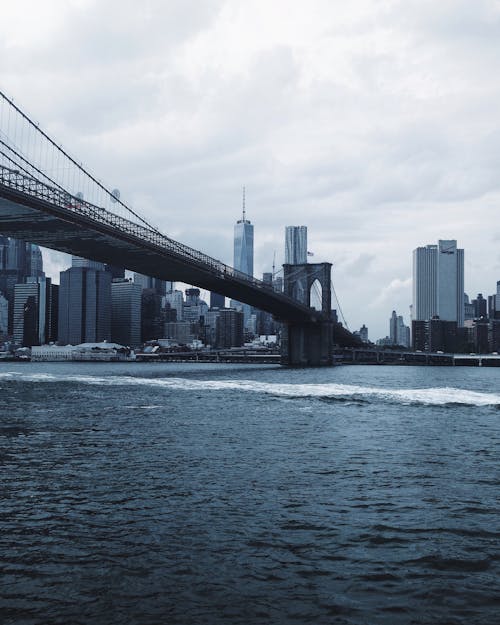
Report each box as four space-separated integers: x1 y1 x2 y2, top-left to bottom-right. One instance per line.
0 169 320 323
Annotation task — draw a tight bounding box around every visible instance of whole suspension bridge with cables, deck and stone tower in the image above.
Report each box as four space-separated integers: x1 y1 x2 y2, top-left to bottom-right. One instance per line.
0 91 357 366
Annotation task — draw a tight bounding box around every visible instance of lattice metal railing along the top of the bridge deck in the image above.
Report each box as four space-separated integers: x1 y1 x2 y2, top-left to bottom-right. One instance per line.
0 165 316 312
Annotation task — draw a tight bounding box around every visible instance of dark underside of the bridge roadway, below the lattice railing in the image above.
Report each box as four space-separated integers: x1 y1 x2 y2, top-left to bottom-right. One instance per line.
0 188 315 323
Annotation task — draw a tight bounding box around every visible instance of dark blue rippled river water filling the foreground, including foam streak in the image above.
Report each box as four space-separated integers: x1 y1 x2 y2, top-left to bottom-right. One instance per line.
0 363 500 625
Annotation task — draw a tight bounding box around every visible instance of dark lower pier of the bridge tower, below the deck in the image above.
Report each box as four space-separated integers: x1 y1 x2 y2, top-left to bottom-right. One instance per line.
281 321 333 367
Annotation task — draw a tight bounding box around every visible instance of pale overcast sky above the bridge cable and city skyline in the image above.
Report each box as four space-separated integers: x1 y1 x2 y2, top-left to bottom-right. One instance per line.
0 0 500 340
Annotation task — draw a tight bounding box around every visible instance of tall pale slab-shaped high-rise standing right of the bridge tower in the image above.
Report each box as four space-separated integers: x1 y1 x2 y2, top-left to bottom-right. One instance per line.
412 240 464 326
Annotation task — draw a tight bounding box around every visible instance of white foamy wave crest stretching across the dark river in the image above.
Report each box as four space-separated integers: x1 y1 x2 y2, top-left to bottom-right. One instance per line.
0 371 500 406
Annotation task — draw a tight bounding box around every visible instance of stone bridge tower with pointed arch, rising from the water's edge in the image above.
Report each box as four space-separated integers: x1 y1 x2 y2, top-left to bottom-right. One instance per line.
281 263 333 367
